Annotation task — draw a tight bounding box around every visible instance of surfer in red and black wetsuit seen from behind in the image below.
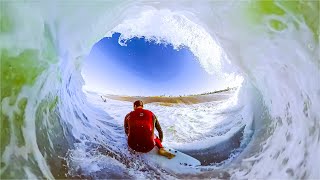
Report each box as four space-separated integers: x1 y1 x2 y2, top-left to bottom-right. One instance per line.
124 100 175 159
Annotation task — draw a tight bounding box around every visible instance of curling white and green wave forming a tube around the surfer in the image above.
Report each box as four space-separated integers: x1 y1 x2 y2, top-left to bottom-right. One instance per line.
0 1 320 179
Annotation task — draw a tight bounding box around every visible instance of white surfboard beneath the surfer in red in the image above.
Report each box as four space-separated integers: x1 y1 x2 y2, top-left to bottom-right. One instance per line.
141 147 201 174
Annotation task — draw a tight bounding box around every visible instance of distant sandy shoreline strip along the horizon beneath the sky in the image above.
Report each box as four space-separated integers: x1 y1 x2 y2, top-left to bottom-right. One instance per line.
101 88 236 106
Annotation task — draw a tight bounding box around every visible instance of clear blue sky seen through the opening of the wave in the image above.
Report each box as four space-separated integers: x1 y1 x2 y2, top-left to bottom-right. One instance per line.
82 33 228 96
